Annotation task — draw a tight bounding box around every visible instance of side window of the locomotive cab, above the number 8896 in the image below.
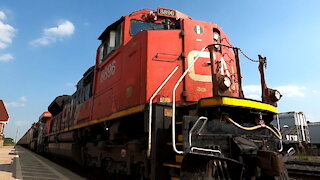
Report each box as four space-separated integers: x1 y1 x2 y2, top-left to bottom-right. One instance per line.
99 23 123 64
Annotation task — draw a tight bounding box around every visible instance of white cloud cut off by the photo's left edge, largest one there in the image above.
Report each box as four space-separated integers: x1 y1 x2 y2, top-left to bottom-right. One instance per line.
0 15 17 49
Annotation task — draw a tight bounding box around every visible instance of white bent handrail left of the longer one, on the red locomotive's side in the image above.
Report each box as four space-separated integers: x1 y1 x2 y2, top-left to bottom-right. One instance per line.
147 65 179 157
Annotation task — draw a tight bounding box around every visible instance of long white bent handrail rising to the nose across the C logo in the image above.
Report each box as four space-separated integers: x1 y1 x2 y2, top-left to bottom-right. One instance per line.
171 46 208 154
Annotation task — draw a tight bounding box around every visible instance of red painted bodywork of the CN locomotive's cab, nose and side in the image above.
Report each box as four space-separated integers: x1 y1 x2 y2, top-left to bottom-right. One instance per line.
40 9 240 133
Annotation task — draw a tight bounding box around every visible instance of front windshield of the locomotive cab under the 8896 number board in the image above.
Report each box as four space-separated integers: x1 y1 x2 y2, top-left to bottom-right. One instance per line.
130 19 179 35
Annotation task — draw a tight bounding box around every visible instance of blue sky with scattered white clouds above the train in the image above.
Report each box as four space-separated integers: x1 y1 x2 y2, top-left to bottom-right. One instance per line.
0 0 320 140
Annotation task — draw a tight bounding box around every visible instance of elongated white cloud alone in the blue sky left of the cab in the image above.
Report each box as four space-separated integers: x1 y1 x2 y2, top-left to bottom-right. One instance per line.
30 21 75 46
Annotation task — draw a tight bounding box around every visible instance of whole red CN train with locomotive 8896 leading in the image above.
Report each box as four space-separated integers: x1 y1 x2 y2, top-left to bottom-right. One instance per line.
19 8 287 180
